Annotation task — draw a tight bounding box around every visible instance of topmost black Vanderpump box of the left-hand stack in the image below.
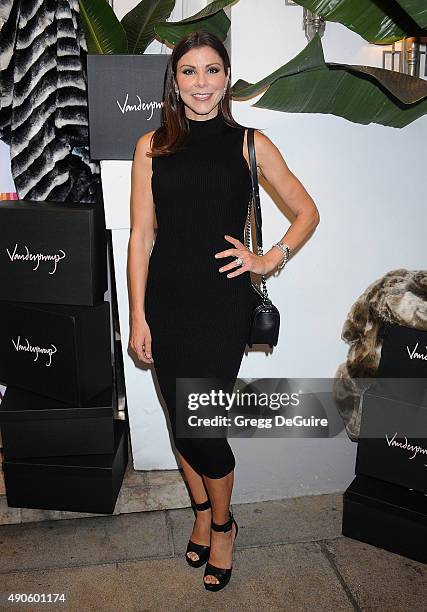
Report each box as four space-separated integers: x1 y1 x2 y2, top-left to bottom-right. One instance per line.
0 200 107 306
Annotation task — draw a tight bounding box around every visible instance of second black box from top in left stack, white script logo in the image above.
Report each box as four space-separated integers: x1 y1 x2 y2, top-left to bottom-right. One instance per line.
0 302 112 406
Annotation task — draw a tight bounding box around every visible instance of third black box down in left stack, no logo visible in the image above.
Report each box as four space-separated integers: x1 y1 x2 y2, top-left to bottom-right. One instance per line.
0 386 117 459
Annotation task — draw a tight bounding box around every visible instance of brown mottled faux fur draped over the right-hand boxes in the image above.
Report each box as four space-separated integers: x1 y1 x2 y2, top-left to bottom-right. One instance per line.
334 268 427 442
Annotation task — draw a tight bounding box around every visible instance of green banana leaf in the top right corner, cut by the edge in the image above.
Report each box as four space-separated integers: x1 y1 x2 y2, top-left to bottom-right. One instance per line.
295 0 426 45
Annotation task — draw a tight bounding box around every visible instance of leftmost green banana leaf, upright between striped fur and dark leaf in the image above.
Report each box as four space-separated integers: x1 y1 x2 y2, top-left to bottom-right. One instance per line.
79 0 128 54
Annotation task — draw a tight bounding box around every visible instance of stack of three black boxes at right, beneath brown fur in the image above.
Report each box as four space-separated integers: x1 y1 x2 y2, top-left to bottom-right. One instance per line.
342 325 427 563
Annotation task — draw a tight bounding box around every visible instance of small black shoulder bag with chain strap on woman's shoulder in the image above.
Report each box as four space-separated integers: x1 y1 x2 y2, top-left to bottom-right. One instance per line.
245 128 280 348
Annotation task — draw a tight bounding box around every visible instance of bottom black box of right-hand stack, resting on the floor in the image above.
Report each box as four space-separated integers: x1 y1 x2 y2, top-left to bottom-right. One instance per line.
342 475 427 563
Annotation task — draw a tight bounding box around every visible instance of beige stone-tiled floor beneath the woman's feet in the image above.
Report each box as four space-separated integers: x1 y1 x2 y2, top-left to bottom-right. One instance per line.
0 492 427 612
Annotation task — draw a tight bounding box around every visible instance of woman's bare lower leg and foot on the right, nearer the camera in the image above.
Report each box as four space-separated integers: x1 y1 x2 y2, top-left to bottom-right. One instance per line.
203 470 236 584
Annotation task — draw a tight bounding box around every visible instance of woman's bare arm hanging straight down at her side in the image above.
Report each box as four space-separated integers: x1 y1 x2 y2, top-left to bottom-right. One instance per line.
128 132 154 363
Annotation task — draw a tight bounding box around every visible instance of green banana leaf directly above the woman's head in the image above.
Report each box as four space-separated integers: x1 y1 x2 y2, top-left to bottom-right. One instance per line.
154 0 235 46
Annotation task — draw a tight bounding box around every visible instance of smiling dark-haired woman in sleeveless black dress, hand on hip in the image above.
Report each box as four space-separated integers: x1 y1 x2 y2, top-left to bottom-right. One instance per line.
128 31 319 591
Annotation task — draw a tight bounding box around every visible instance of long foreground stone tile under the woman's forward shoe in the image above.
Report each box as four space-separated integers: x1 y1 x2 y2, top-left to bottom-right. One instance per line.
2 543 353 612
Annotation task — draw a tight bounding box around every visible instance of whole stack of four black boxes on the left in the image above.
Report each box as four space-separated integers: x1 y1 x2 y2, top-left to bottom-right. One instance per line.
0 201 127 513
